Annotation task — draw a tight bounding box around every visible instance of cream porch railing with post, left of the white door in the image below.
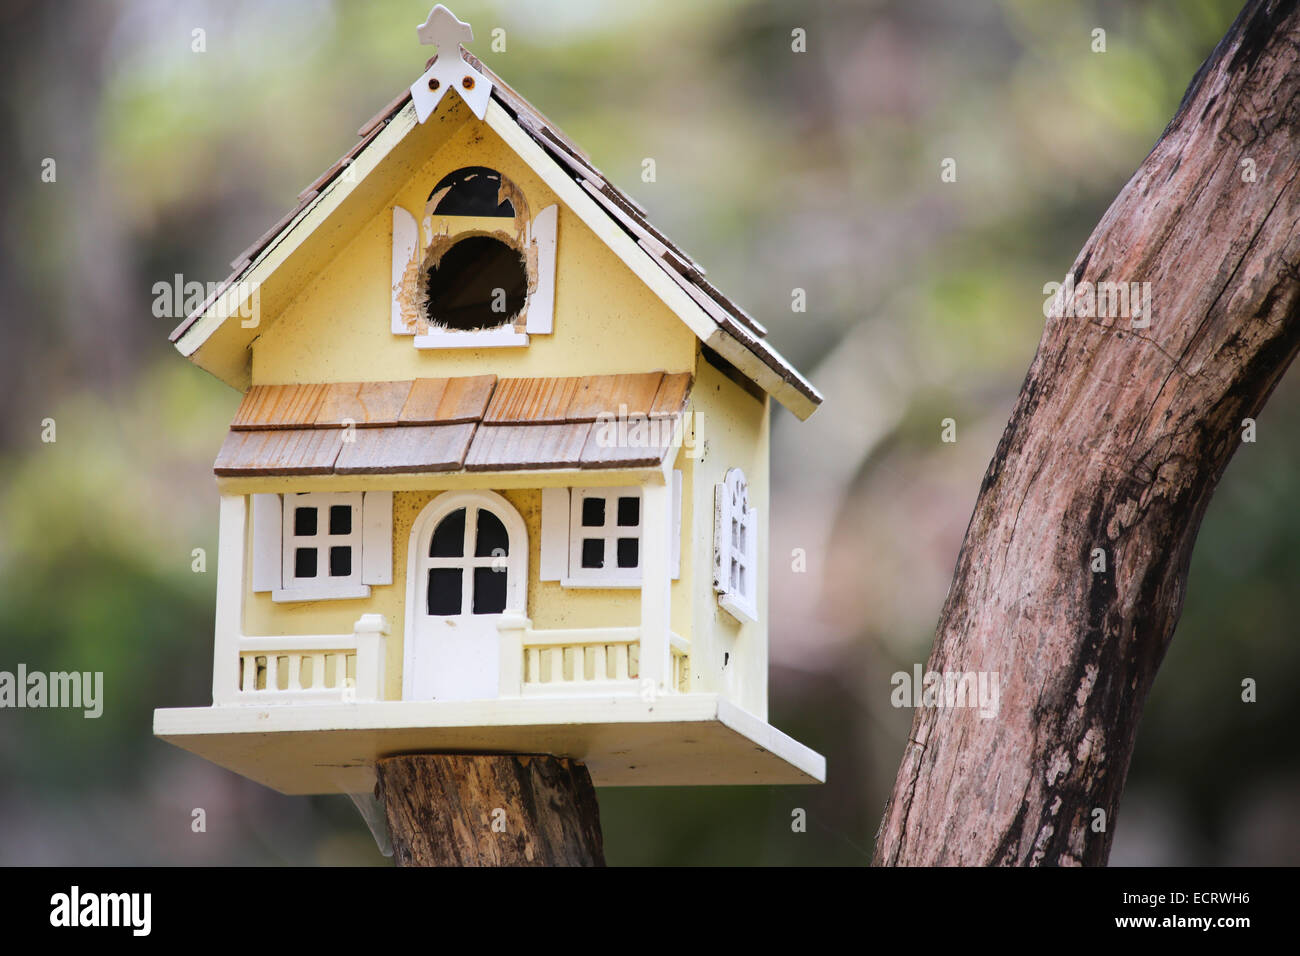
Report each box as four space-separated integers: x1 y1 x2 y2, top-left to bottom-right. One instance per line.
231 614 389 704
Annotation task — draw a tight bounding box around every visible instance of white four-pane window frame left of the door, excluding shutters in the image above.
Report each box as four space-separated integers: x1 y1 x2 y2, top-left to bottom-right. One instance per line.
272 492 371 602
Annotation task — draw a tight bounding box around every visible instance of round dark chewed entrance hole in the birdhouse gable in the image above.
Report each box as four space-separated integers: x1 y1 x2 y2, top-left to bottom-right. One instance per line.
425 235 528 332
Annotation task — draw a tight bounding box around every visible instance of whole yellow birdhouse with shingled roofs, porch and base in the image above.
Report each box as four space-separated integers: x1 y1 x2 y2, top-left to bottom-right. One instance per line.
155 7 826 793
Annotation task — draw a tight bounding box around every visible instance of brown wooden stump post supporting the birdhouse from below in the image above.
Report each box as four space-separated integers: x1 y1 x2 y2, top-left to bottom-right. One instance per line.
376 753 605 866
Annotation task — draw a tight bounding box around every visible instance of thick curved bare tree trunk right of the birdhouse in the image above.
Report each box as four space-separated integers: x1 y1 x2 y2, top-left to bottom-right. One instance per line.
875 0 1300 865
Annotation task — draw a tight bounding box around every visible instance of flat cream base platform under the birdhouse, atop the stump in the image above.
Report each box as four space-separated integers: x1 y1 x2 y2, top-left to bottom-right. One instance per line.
153 693 826 793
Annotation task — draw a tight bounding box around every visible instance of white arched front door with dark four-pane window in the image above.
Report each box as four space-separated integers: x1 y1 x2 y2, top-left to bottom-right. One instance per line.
402 492 528 700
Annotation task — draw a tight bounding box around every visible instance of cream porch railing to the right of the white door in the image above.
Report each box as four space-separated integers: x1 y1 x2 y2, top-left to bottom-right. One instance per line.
509 627 690 693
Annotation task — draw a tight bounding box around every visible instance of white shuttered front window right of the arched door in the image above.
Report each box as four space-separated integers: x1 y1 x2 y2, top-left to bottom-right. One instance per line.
540 471 681 588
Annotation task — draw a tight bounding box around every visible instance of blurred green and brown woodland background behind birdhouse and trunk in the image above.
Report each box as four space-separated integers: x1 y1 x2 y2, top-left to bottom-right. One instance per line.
0 0 1300 865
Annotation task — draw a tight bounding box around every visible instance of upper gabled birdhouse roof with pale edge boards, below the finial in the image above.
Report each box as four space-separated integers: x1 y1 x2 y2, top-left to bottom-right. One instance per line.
170 49 822 419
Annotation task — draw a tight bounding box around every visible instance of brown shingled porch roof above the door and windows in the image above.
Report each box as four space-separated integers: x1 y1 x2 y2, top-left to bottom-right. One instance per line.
215 372 690 477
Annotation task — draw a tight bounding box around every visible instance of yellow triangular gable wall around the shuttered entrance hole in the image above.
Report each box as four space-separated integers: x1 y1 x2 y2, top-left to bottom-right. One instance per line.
252 111 696 385
